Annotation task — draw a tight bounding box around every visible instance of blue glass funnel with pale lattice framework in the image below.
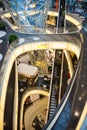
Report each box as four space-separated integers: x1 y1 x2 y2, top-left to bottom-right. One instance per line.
4 0 49 31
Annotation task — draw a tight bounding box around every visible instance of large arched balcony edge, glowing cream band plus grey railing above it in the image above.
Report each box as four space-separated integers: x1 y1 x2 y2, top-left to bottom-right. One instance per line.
0 31 81 130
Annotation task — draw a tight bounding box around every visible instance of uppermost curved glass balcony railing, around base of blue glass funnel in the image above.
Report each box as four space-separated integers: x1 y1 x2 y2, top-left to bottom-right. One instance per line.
1 12 82 34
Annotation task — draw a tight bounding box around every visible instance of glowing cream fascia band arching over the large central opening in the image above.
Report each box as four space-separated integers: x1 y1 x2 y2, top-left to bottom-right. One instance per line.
0 41 81 130
